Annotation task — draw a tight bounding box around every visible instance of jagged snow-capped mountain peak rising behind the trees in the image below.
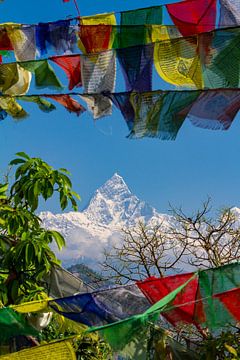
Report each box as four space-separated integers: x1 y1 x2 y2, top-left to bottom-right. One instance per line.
40 174 171 264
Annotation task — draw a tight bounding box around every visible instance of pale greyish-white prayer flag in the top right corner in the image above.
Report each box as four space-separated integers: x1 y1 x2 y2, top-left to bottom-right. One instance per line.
219 0 240 28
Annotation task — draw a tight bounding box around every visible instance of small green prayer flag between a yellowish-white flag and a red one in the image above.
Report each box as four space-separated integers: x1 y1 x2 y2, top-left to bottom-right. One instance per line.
19 60 62 89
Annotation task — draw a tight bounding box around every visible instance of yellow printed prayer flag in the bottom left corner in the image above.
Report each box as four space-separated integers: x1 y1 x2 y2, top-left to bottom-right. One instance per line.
0 340 77 360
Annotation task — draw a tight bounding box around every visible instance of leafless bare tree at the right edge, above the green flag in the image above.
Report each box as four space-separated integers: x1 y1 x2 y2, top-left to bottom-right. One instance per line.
169 198 240 268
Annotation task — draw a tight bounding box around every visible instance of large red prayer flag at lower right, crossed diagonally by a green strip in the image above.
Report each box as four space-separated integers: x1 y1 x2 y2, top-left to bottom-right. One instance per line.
137 273 198 325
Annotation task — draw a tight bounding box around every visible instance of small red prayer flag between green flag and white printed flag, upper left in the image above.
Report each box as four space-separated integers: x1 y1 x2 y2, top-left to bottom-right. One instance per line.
51 55 82 90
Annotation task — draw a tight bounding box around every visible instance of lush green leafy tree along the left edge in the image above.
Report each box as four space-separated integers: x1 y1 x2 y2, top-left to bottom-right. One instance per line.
0 152 79 305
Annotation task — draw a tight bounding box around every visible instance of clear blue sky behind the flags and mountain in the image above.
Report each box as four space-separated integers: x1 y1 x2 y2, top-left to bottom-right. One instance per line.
0 0 240 212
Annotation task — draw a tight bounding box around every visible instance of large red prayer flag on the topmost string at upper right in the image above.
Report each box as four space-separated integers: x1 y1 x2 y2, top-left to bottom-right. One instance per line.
166 0 217 36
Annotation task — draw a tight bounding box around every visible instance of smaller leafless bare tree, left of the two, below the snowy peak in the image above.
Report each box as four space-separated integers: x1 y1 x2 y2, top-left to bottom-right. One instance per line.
102 222 187 283
